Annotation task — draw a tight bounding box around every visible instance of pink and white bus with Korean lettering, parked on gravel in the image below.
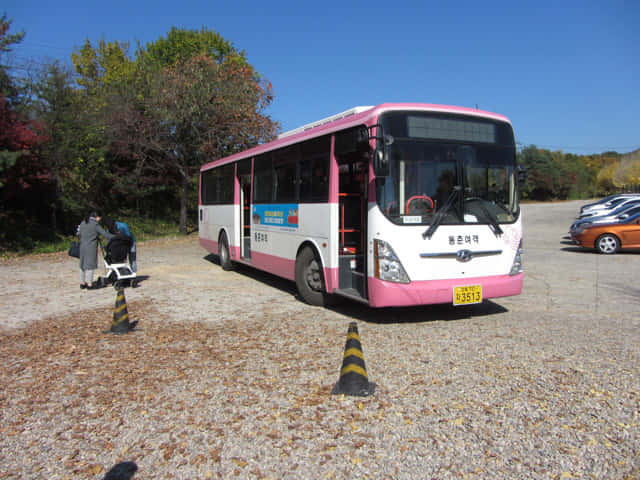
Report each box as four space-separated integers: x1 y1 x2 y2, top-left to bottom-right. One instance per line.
199 103 523 307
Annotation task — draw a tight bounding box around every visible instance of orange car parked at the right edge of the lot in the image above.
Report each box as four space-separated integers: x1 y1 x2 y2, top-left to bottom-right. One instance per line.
571 214 640 254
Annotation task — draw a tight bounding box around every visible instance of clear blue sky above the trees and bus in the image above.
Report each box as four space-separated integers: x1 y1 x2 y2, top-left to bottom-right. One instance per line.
5 0 640 154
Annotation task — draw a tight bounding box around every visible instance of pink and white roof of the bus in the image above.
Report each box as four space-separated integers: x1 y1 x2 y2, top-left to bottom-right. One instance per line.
200 103 511 171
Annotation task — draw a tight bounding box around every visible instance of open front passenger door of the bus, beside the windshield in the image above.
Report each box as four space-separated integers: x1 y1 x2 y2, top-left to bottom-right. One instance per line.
337 152 367 299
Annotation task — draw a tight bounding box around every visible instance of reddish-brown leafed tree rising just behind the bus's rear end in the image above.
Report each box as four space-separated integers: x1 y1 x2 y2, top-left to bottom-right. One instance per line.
149 55 277 232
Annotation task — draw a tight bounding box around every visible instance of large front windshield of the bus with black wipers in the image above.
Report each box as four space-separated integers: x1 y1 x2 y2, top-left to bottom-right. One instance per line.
376 112 519 225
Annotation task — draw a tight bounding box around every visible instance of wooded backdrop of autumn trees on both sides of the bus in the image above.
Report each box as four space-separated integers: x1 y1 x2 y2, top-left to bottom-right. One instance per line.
0 14 640 254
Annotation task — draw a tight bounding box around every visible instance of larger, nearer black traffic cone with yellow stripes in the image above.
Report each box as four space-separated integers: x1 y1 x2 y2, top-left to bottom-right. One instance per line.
331 322 376 397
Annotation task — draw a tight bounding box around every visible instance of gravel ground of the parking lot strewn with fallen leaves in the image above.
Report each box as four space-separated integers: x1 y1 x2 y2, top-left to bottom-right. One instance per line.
0 202 640 479
